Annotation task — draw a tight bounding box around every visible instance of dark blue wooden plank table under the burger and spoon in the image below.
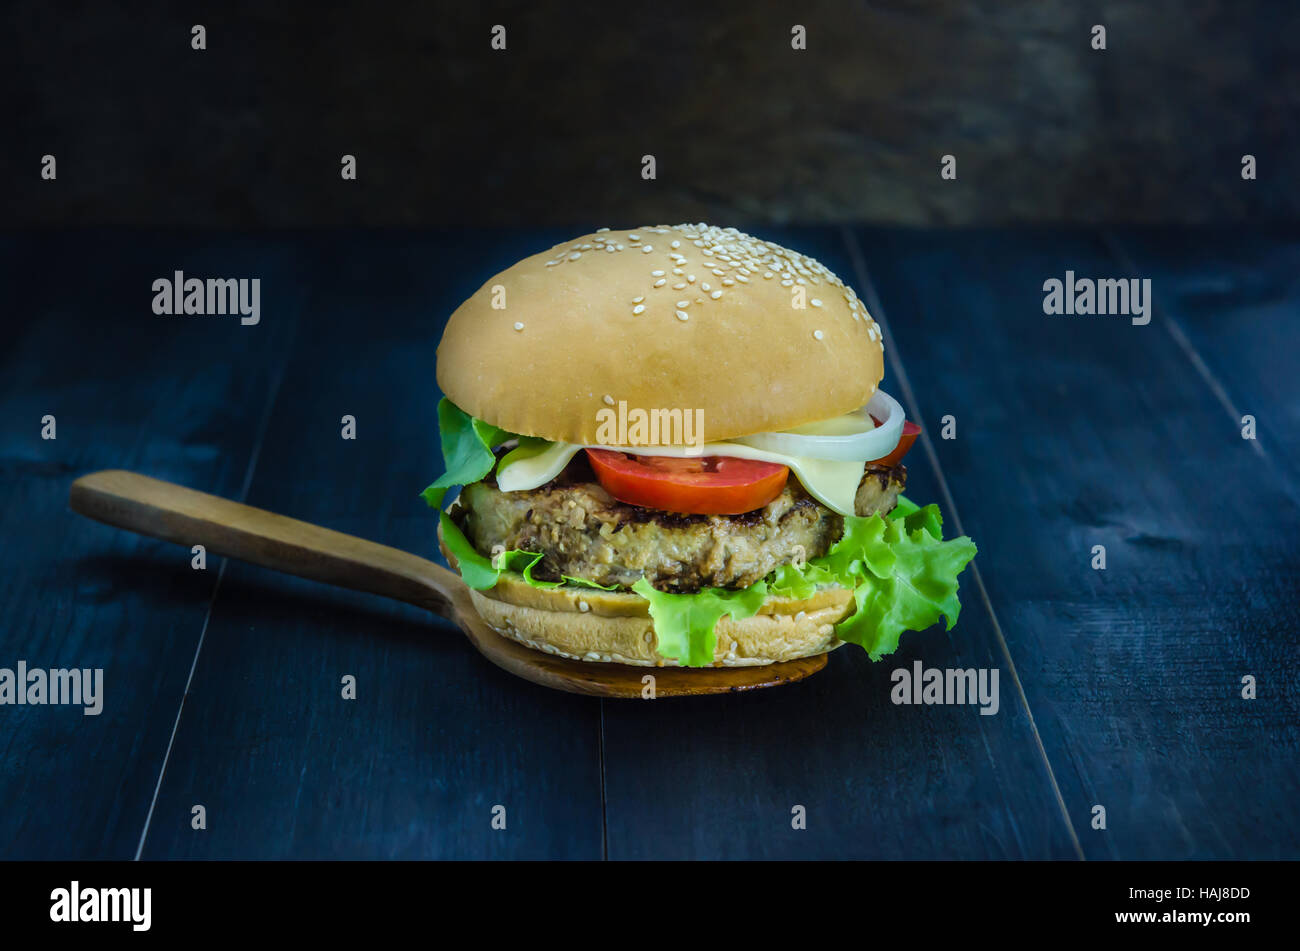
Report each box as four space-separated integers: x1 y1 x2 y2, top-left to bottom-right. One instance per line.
0 222 1300 859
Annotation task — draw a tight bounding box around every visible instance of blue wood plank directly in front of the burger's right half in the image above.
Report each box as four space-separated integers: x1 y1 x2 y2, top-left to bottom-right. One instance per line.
605 229 1078 859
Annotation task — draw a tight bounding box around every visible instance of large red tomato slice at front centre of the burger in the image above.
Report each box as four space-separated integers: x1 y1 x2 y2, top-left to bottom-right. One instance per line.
586 450 790 514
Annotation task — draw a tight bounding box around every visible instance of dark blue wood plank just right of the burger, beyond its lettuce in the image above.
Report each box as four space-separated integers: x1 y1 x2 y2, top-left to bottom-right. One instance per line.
858 231 1300 859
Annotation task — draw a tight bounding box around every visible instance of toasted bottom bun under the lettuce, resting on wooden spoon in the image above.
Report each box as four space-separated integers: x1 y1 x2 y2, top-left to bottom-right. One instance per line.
438 531 854 666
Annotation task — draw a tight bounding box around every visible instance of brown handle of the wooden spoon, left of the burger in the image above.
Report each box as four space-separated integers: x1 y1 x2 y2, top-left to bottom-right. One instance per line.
68 469 462 617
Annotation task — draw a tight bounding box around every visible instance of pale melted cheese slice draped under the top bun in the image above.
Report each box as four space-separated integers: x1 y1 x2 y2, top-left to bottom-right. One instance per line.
497 443 867 516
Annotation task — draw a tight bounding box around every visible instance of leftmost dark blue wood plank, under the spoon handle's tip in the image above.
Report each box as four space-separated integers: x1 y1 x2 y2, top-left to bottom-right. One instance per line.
0 233 303 859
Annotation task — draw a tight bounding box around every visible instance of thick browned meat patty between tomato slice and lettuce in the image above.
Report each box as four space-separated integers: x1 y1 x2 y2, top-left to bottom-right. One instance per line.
451 453 907 592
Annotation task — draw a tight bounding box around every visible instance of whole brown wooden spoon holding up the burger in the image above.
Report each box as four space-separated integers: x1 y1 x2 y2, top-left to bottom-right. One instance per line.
68 469 826 698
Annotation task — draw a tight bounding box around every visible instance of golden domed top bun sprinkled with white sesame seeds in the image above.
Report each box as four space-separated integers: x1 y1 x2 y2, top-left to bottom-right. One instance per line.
437 225 884 443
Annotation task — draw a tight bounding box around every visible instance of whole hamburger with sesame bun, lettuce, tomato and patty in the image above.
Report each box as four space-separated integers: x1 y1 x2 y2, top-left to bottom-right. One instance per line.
423 223 975 666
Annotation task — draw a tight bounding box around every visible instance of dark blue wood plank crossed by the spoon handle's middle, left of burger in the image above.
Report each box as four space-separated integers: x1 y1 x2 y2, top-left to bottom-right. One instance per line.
135 234 603 859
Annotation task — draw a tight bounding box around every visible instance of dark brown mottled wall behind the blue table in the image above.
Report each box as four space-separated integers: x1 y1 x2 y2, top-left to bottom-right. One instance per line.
0 0 1300 229
